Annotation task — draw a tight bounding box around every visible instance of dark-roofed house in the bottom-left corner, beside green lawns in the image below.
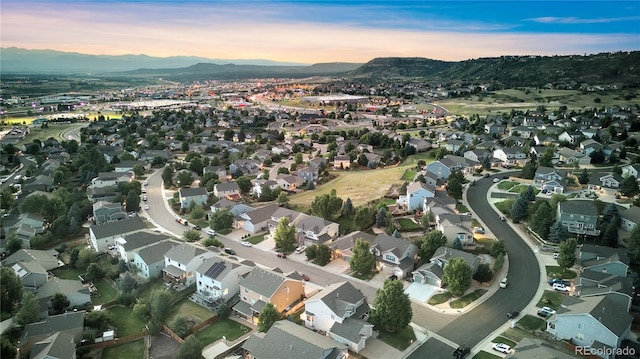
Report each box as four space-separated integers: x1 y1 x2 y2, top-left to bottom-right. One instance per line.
20 310 86 358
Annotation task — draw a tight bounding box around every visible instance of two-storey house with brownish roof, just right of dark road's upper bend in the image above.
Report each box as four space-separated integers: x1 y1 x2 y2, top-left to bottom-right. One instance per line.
556 200 600 236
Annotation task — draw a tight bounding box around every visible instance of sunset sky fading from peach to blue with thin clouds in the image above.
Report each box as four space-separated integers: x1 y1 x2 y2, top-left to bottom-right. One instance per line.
0 0 640 63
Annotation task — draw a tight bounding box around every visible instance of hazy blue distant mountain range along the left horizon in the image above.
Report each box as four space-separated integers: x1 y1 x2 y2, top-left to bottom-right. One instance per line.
0 47 309 74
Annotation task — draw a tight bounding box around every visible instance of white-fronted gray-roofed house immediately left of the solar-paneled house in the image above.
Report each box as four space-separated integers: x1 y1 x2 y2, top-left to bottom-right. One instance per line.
162 243 216 286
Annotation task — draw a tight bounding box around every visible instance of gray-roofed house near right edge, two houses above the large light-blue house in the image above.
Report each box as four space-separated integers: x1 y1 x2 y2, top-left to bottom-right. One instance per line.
577 244 630 277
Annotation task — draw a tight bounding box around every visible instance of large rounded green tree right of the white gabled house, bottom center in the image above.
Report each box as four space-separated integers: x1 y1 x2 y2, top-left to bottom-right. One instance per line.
370 279 413 333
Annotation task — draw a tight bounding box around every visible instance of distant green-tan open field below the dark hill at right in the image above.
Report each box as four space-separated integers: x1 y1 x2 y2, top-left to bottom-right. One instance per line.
436 88 635 115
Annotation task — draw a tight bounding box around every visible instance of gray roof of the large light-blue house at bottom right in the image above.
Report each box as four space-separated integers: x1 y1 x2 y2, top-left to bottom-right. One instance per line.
557 294 633 336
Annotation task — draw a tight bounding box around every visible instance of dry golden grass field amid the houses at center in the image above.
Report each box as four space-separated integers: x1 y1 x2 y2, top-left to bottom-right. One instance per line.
289 152 435 208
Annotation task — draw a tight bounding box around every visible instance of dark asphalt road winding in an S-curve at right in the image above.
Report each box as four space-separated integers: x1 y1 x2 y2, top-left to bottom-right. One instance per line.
409 174 540 358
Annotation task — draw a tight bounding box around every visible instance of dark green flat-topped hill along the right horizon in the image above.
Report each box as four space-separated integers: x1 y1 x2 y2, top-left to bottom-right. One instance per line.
348 51 640 86
